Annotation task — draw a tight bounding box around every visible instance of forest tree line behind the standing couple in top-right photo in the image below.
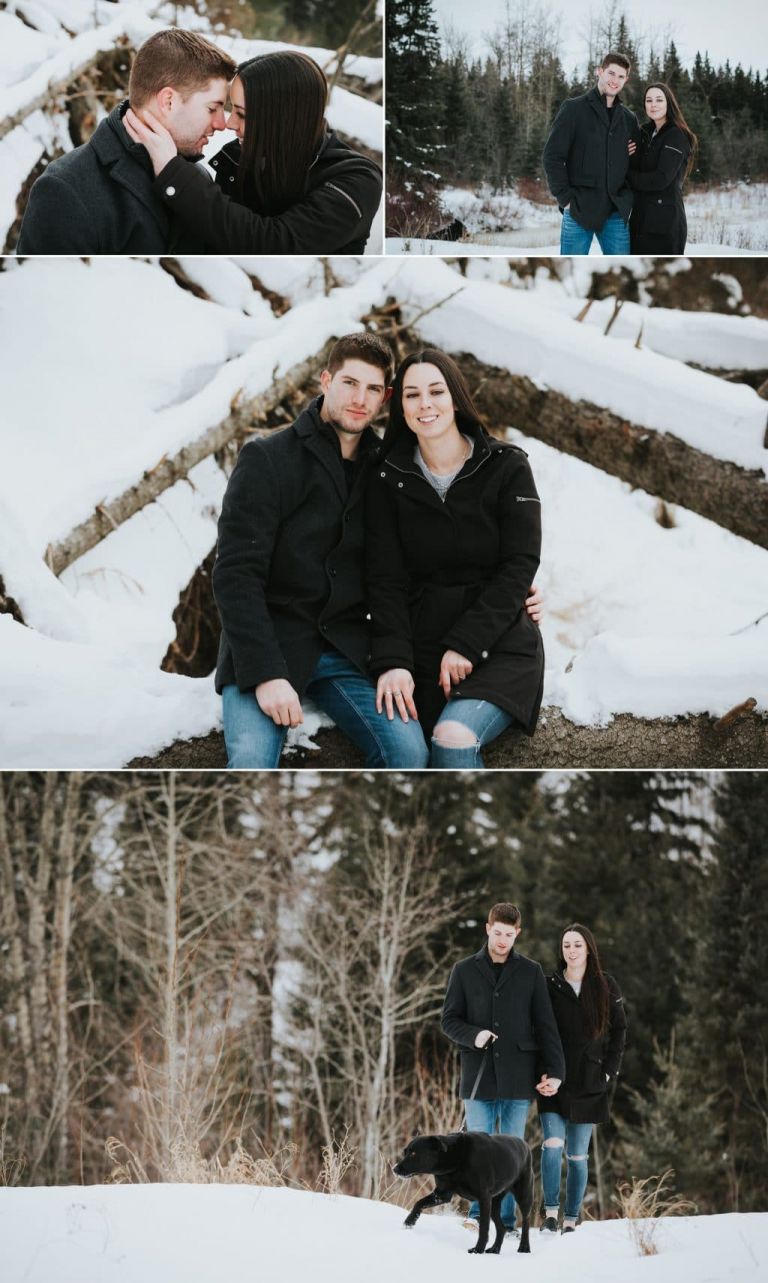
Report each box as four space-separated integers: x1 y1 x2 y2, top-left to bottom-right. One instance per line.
387 0 768 219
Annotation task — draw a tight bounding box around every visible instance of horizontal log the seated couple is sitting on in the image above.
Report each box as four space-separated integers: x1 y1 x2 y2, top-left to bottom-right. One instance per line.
126 708 768 770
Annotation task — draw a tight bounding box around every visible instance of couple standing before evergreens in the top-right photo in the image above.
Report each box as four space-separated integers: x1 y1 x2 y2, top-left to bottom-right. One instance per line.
544 53 697 254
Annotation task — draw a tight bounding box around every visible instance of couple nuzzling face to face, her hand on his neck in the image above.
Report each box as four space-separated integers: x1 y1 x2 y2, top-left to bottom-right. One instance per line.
17 28 382 255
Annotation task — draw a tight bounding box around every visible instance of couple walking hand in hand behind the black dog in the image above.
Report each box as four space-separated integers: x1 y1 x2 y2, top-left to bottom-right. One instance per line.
442 903 627 1234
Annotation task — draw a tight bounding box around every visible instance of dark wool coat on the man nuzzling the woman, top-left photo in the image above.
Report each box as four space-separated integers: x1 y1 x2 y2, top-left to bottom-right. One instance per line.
17 101 204 255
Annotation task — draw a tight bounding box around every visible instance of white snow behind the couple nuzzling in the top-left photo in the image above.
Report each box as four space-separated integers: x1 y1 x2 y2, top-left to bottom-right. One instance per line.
0 0 383 254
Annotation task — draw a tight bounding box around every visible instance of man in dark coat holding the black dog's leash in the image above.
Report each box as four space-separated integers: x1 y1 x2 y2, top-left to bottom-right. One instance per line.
441 903 565 1230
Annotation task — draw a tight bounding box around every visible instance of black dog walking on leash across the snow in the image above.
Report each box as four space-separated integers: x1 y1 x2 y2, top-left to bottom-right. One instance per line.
392 1132 533 1252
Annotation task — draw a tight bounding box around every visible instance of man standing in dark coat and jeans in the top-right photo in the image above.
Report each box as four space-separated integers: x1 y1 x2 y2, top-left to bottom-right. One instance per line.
544 53 640 254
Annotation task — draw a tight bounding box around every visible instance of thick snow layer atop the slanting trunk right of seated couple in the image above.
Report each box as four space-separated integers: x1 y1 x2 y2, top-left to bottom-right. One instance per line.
389 259 768 473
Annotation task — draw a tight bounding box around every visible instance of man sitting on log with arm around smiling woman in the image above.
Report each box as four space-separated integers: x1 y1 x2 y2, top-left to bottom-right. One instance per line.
213 334 538 770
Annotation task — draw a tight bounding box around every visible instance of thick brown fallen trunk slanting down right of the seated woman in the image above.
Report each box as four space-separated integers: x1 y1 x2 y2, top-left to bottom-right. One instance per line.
456 353 768 548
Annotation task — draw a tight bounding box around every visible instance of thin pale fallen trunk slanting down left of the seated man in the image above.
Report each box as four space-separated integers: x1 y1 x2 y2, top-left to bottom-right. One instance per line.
45 352 324 575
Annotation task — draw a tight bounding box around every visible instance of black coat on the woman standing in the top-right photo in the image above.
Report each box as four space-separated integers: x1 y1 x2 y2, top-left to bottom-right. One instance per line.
628 122 691 254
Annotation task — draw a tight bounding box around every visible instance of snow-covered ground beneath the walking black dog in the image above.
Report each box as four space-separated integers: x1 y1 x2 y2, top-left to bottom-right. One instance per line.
0 1185 768 1283
